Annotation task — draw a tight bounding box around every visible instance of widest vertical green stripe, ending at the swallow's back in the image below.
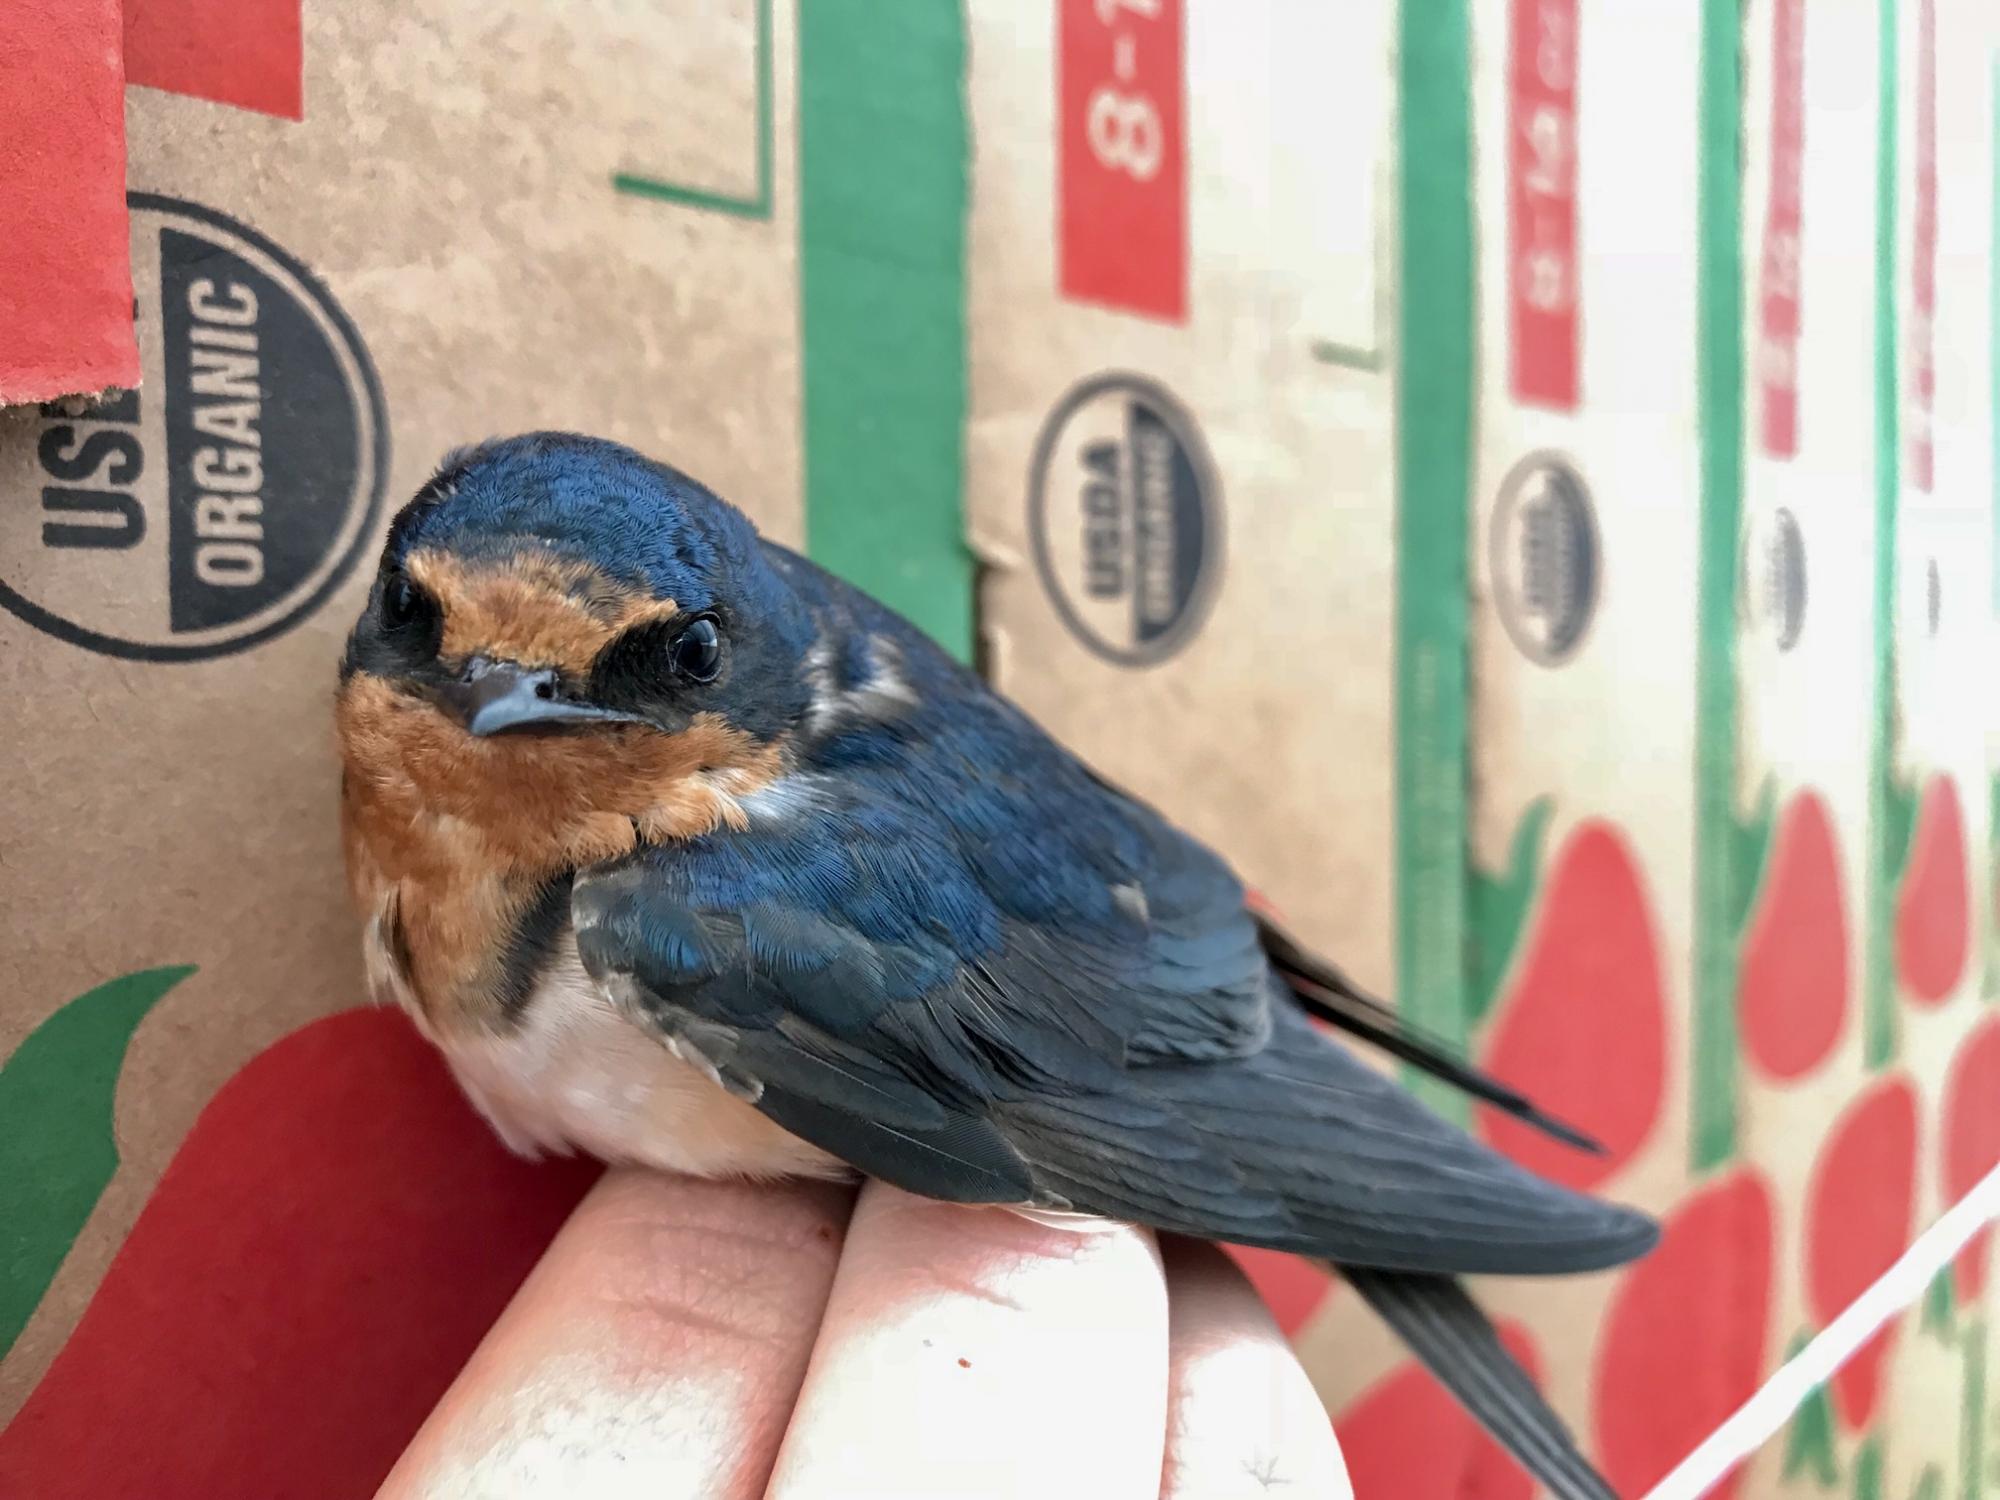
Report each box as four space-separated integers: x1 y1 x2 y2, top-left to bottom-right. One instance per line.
798 0 972 660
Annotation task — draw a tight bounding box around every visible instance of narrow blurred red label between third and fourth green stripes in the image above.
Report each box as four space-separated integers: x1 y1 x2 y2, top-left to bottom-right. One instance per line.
1758 0 1806 458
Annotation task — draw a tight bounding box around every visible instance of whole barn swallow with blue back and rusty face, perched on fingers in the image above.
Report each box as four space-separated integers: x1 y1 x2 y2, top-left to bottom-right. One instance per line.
336 434 1656 1500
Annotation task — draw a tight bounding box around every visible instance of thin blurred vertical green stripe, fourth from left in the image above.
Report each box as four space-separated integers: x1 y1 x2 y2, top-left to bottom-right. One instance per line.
1862 0 1904 1068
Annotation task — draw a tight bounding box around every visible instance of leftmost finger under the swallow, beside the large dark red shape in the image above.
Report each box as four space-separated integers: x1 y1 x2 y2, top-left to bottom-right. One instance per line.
380 1168 854 1500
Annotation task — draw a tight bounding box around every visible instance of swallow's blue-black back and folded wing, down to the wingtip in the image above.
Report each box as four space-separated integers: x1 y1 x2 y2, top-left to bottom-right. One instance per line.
574 560 1654 1272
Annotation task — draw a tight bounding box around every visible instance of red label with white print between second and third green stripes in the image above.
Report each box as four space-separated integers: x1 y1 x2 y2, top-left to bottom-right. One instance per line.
1508 0 1578 412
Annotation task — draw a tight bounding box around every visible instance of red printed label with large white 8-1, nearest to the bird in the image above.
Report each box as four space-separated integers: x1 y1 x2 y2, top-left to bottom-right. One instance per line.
1056 0 1188 322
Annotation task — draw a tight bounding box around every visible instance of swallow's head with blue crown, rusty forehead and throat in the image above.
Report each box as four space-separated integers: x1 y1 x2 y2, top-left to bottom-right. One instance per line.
338 432 816 864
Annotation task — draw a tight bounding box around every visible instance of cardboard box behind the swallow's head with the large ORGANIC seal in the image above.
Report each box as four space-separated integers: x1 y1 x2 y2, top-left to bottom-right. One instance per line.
0 0 970 1496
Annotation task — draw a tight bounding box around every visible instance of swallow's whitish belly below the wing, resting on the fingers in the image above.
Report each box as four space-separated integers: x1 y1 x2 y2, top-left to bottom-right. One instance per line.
436 936 852 1178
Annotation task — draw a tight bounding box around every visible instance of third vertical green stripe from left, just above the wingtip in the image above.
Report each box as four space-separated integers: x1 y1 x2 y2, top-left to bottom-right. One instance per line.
1690 0 1744 1172
